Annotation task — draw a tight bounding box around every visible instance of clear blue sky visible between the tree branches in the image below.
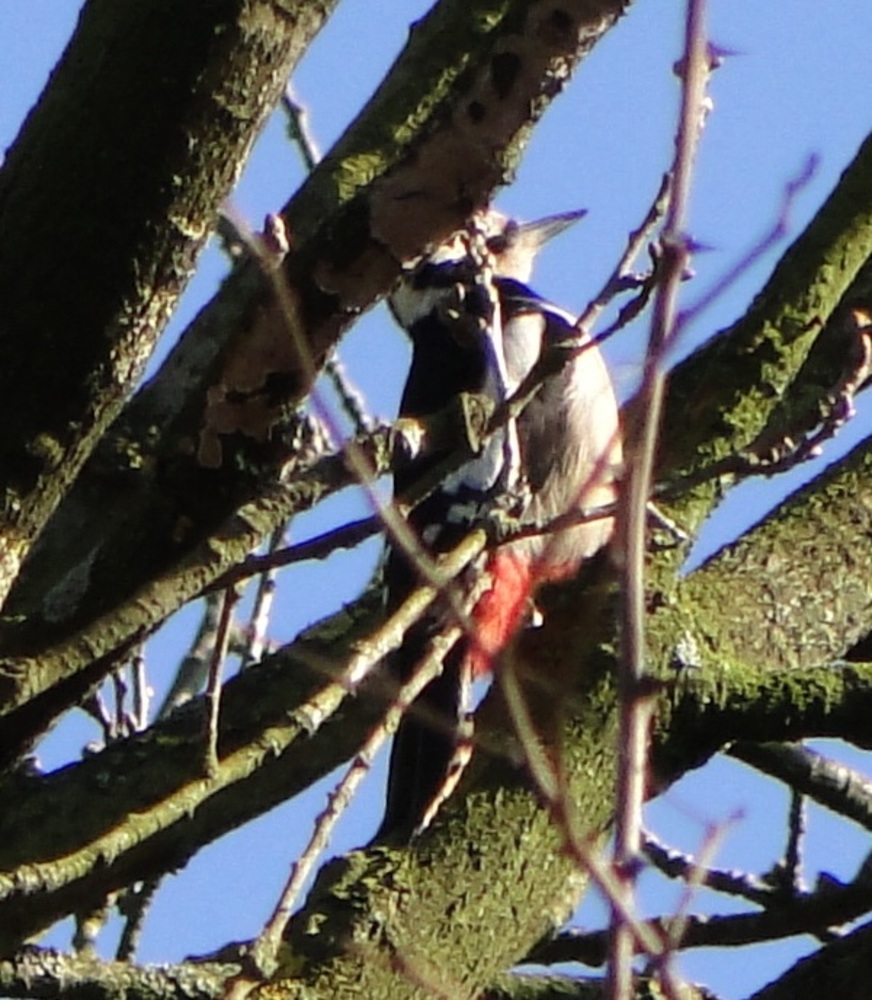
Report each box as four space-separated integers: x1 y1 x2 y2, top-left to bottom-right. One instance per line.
0 0 872 998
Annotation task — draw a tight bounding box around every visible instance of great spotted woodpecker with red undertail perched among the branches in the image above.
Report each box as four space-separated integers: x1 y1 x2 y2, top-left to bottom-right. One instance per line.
378 209 621 839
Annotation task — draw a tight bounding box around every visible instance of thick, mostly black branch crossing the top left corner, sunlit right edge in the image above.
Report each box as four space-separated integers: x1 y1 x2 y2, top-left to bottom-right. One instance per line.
0 0 333 603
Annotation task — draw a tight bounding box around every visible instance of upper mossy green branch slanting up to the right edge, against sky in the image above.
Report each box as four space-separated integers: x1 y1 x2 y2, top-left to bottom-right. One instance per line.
659 130 872 558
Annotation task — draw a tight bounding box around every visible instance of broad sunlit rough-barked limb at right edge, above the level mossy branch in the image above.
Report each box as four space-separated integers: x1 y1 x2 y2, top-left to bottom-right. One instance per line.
651 430 872 688
